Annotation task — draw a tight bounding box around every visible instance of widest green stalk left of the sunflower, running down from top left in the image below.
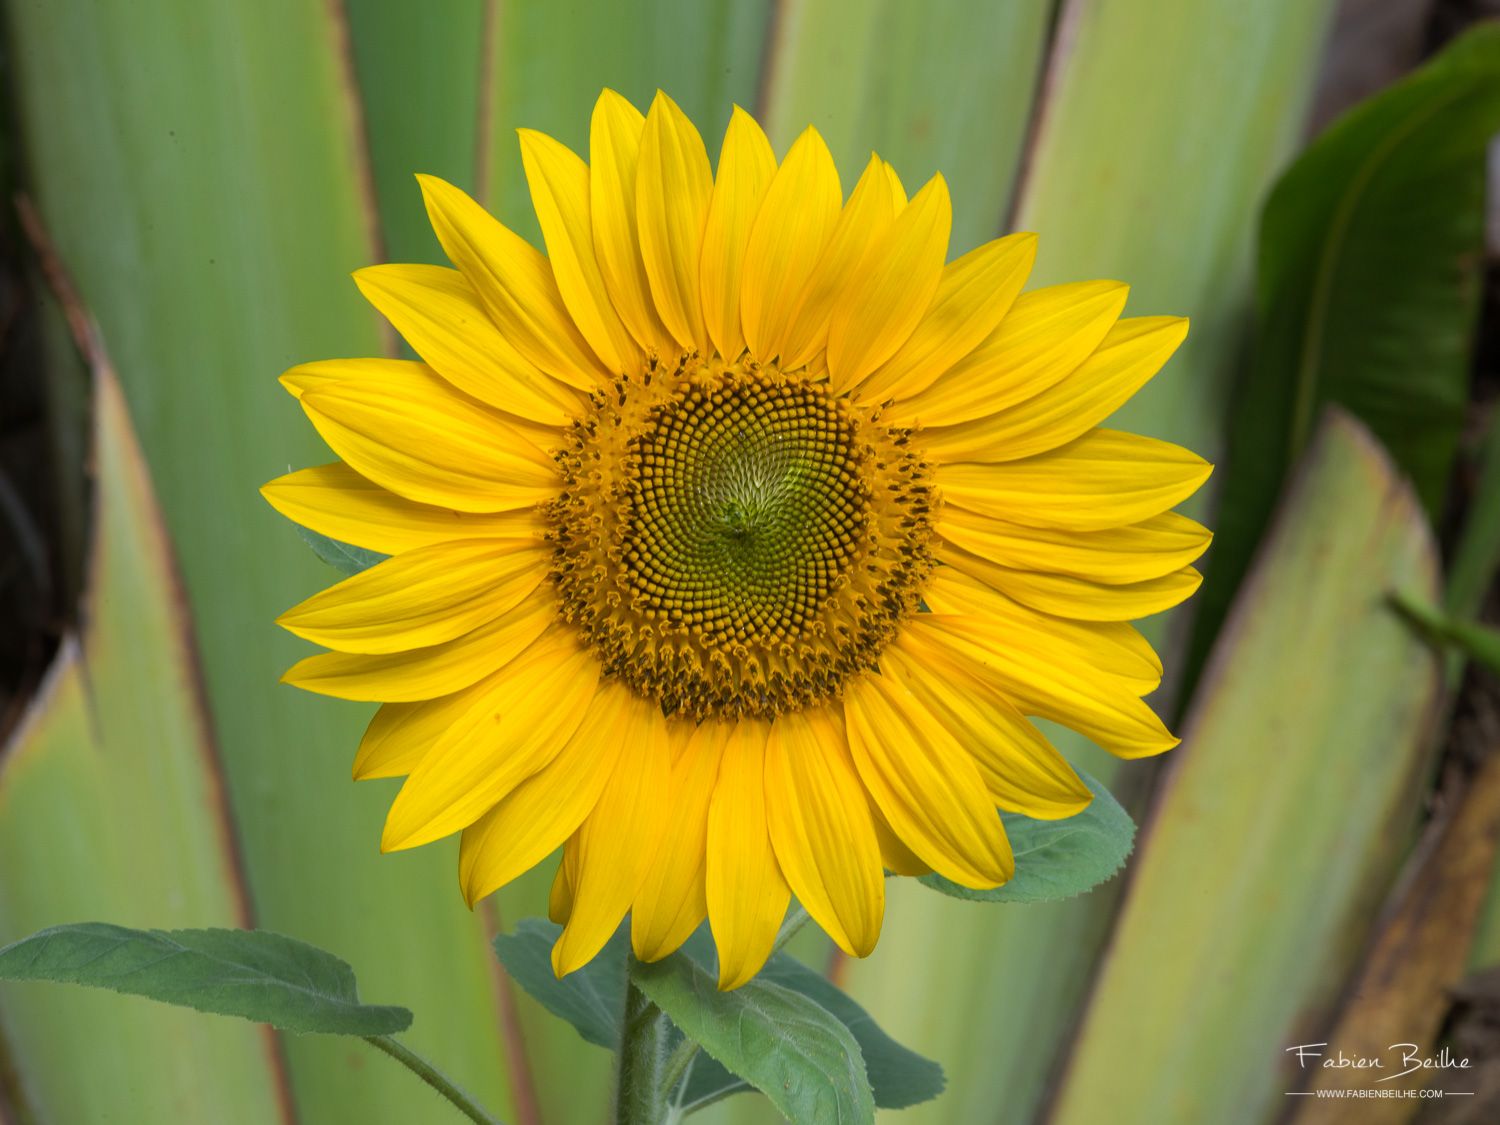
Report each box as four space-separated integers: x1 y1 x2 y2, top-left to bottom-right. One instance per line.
8 0 507 1124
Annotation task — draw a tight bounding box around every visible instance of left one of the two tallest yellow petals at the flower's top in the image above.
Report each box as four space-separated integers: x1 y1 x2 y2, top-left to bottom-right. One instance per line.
588 90 672 351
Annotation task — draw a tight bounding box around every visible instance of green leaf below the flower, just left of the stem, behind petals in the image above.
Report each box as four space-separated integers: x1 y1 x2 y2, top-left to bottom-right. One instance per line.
495 918 630 1050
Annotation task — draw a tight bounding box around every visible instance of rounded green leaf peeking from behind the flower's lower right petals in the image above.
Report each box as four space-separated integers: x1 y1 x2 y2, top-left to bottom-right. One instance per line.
921 771 1136 903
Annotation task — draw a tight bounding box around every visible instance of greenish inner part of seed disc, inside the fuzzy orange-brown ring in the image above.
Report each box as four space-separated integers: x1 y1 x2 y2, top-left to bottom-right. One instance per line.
623 378 867 641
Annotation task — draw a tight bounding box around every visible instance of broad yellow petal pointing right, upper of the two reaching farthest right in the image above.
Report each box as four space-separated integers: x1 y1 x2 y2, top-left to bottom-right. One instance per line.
938 429 1214 531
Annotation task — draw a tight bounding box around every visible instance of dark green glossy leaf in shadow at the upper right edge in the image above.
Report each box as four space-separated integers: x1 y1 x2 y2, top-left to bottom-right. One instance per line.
1193 24 1500 687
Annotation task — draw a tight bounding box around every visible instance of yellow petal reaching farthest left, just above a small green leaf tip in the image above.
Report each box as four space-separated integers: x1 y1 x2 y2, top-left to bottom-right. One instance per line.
261 461 546 555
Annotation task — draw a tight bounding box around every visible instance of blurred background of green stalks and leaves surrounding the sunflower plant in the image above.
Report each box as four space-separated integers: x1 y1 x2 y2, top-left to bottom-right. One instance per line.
0 0 1500 1125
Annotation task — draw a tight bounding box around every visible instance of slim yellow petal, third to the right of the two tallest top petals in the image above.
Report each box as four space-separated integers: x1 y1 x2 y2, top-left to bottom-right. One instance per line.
782 156 902 369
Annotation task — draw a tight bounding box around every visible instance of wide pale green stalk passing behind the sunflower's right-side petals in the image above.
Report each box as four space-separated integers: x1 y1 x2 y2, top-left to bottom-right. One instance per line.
848 0 1334 1125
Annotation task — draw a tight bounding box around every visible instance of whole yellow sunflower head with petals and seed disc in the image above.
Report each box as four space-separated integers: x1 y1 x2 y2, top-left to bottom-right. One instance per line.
264 90 1211 989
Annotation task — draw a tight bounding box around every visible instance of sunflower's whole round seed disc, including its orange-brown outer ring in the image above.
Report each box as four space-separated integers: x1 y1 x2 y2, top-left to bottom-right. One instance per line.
548 357 933 719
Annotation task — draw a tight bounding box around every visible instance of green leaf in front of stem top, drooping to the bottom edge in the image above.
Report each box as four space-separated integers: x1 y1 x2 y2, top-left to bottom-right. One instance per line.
635 953 875 1125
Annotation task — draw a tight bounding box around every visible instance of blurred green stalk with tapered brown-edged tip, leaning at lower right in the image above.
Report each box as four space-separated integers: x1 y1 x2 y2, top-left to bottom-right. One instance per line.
1056 414 1443 1125
